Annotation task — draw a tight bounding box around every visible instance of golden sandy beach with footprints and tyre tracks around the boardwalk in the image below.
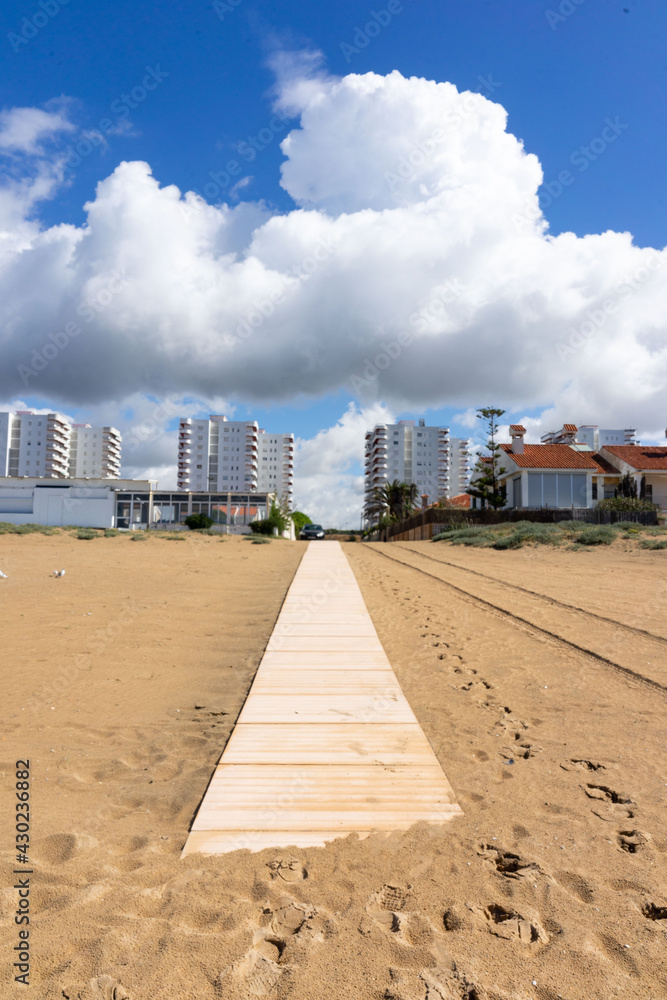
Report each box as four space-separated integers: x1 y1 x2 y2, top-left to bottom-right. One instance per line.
0 533 667 1000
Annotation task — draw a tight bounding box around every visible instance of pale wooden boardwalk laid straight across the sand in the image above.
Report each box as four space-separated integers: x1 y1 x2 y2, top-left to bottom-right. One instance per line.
183 542 461 855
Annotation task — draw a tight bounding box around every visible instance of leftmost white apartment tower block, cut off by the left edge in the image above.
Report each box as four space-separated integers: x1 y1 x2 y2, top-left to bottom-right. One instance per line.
0 410 71 479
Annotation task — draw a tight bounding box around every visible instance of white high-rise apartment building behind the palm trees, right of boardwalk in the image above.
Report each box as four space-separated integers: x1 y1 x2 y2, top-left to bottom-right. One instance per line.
364 420 471 503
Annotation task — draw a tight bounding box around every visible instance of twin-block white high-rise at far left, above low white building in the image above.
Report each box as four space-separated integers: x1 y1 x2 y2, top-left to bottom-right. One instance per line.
0 410 121 479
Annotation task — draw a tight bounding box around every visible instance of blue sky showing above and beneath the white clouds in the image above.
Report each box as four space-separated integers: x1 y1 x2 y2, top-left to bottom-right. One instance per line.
0 0 667 528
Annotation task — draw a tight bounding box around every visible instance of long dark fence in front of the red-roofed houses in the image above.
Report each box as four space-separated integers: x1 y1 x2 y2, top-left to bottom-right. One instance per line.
366 507 658 542
